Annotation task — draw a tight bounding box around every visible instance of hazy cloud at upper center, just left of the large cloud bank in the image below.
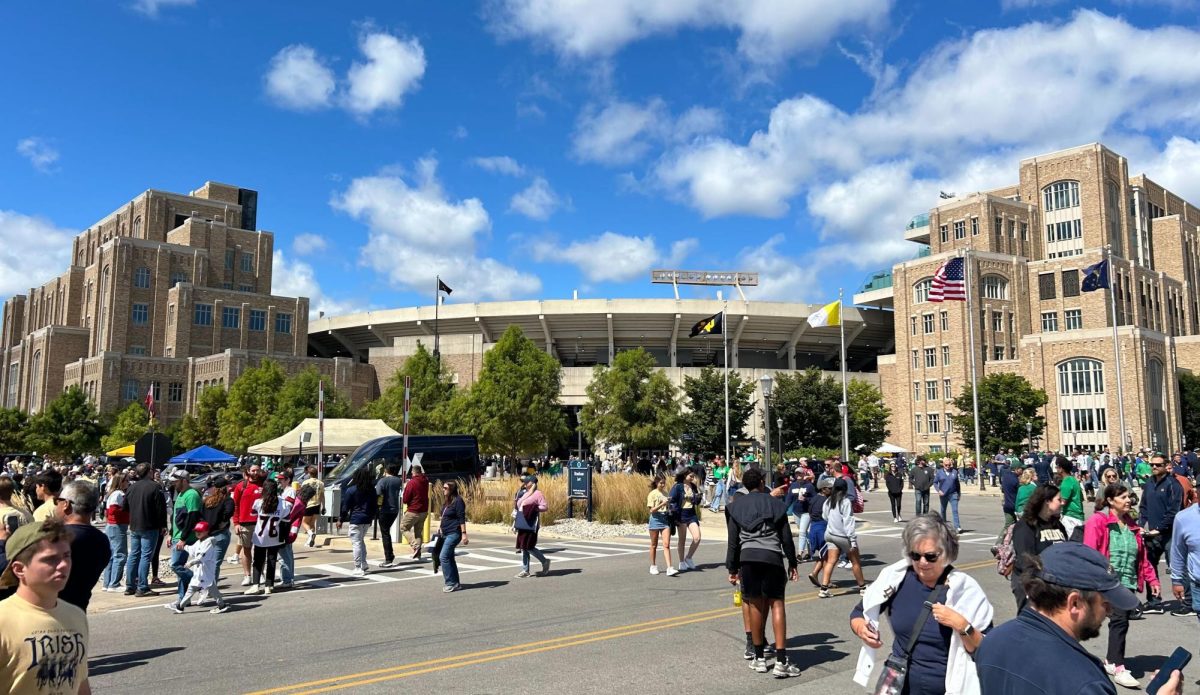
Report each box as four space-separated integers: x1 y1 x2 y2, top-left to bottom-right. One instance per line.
572 98 721 164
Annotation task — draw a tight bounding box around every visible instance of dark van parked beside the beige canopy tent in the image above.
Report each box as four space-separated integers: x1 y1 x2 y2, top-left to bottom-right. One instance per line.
325 435 482 487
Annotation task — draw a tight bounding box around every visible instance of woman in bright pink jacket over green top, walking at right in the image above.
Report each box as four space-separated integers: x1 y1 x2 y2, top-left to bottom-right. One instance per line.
1084 484 1160 688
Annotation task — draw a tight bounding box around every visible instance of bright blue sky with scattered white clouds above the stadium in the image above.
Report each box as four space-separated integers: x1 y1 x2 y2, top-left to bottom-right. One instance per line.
0 0 1200 313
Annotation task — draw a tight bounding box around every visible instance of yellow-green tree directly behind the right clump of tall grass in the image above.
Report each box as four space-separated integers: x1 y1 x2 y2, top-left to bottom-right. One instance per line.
580 348 686 453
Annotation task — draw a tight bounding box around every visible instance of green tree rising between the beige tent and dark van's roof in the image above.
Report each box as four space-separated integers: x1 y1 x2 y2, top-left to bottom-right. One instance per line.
364 341 454 435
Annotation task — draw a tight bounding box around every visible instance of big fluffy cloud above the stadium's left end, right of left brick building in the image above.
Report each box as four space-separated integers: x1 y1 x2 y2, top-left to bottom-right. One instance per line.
330 160 541 300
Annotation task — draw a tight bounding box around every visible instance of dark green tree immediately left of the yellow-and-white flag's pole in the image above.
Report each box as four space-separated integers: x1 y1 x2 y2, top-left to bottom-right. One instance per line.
770 367 841 451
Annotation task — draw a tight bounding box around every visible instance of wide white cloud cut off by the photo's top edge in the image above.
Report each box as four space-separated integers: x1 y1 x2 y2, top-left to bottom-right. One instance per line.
488 0 892 62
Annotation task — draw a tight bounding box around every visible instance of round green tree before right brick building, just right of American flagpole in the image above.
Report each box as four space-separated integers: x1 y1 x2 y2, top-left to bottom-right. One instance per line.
952 372 1048 456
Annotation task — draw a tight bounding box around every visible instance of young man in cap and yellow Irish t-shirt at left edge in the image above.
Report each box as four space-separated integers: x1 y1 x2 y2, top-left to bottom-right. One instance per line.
0 519 91 695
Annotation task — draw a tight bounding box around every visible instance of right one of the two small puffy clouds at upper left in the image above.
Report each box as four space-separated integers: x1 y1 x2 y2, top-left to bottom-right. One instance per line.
343 31 425 116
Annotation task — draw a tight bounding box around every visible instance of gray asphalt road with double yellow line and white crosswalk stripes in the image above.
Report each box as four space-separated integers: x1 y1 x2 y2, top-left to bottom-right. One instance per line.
89 495 1200 695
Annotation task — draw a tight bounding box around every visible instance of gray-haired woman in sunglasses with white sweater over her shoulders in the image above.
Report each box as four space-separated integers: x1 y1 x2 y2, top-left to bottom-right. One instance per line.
850 514 994 695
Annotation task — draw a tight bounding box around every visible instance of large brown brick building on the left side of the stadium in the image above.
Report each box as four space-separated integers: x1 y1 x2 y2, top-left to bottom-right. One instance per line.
0 181 374 424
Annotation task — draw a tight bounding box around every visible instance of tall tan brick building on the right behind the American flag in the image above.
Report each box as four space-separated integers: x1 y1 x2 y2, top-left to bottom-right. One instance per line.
856 144 1200 451
